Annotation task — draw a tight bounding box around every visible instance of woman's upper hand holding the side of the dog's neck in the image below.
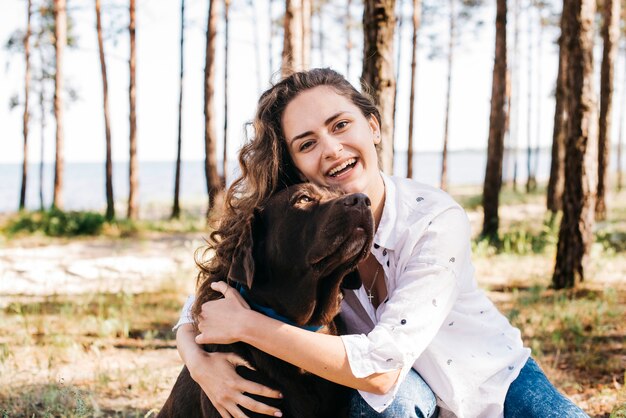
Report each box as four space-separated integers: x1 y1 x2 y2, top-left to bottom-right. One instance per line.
196 282 250 344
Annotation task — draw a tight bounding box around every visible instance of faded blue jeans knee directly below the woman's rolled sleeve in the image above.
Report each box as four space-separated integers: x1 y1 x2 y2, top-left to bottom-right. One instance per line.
349 369 438 418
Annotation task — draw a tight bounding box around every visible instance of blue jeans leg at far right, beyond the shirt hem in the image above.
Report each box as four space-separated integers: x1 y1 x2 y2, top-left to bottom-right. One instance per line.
504 357 589 418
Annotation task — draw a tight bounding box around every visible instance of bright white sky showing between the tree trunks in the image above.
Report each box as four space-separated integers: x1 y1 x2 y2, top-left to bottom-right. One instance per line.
0 0 621 167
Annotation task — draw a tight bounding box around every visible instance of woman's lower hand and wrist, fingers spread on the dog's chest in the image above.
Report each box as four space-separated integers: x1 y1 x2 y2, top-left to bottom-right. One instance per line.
176 324 282 418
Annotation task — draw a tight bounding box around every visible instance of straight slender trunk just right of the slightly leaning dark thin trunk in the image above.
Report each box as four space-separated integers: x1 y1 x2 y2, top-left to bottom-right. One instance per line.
127 0 139 219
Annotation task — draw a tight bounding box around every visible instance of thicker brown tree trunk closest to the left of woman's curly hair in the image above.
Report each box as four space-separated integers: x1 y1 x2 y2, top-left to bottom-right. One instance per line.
204 0 221 218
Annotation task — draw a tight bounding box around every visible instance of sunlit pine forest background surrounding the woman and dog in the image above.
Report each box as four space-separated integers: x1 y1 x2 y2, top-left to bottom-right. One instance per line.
0 0 626 416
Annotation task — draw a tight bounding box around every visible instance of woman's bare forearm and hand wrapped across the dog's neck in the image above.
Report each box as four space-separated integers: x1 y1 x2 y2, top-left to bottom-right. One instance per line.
196 282 400 394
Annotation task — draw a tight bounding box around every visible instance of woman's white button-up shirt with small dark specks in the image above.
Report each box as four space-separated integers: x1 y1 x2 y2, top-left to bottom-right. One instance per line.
341 174 530 418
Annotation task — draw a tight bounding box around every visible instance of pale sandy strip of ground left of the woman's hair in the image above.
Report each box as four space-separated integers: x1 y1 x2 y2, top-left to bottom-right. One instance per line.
0 233 203 303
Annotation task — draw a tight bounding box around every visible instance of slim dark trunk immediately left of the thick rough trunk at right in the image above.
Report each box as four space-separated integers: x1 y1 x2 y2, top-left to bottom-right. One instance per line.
547 7 570 214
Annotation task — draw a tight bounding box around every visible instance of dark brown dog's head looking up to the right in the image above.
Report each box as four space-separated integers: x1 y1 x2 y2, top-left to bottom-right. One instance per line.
229 183 374 325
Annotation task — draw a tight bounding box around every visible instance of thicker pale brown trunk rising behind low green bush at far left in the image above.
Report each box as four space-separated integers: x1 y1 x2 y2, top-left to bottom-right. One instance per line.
52 0 67 209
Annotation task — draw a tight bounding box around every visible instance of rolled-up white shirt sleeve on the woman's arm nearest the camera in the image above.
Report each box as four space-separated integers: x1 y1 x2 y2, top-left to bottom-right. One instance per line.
342 207 471 411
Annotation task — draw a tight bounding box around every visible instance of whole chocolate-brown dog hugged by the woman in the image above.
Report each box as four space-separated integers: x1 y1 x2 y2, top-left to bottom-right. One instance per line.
159 183 373 418
